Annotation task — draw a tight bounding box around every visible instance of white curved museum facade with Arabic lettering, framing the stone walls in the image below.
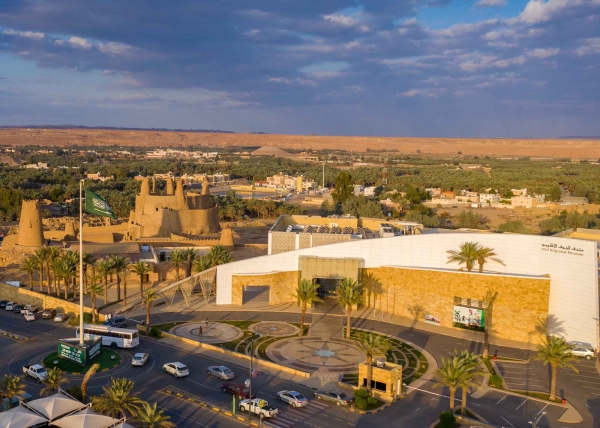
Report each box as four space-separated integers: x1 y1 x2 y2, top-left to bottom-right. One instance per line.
217 233 599 347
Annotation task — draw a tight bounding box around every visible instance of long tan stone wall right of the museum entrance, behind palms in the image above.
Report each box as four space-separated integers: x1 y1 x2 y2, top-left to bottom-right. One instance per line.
363 267 550 343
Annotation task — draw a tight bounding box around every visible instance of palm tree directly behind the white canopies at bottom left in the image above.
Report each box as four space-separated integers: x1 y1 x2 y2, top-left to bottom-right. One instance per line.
92 377 144 418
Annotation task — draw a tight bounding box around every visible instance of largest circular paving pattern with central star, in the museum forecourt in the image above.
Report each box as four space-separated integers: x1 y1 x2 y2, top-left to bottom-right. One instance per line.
265 337 365 373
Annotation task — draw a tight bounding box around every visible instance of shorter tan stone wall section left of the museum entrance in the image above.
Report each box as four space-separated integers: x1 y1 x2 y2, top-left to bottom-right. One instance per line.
231 271 299 305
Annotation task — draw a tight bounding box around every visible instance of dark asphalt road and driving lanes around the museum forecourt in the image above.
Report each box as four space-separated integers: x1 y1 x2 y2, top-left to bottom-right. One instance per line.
0 312 600 428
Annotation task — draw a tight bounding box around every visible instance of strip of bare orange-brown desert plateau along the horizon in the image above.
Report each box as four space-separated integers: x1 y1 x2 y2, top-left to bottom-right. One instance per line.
0 128 600 159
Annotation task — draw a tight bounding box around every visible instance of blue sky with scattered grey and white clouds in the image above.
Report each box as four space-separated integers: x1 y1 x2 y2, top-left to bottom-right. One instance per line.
0 0 600 138
